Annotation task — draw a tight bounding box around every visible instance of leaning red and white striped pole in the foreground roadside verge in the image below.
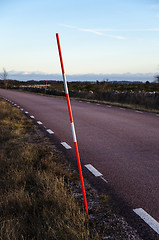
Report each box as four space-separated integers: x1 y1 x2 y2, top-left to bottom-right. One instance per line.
56 33 88 214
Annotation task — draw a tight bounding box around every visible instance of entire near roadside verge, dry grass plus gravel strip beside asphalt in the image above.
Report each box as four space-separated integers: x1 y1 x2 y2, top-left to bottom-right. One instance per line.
0 99 140 240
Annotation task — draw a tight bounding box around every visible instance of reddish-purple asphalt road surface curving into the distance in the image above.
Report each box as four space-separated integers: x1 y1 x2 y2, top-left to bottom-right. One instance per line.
0 89 159 236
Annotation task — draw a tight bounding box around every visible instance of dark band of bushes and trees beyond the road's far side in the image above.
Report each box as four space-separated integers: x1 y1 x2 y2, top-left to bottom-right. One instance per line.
0 76 159 109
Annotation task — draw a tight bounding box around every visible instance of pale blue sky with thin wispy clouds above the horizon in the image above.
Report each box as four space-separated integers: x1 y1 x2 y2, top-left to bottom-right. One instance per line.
0 0 159 80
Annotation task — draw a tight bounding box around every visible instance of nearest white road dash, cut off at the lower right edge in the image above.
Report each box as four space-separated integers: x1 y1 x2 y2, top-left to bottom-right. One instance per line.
133 208 159 234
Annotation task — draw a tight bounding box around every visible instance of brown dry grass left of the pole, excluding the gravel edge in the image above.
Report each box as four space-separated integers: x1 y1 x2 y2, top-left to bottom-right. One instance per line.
0 100 99 240
